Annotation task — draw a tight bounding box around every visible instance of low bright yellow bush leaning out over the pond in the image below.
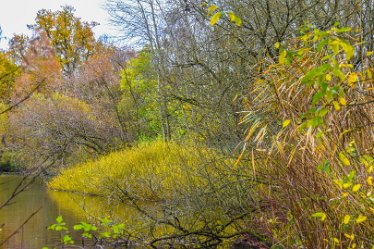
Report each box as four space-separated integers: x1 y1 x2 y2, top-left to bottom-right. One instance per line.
49 141 222 200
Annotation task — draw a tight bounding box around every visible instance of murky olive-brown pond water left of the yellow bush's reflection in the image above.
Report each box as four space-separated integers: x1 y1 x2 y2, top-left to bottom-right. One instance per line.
0 176 81 248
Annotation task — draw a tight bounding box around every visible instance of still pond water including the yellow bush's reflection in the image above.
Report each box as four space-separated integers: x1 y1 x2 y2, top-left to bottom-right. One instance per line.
0 176 222 249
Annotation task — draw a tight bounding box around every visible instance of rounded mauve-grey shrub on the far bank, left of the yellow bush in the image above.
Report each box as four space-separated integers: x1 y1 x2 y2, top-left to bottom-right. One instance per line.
5 93 119 169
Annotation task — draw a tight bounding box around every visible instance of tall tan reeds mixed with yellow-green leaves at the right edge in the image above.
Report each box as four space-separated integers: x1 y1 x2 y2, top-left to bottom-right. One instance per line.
243 27 374 248
